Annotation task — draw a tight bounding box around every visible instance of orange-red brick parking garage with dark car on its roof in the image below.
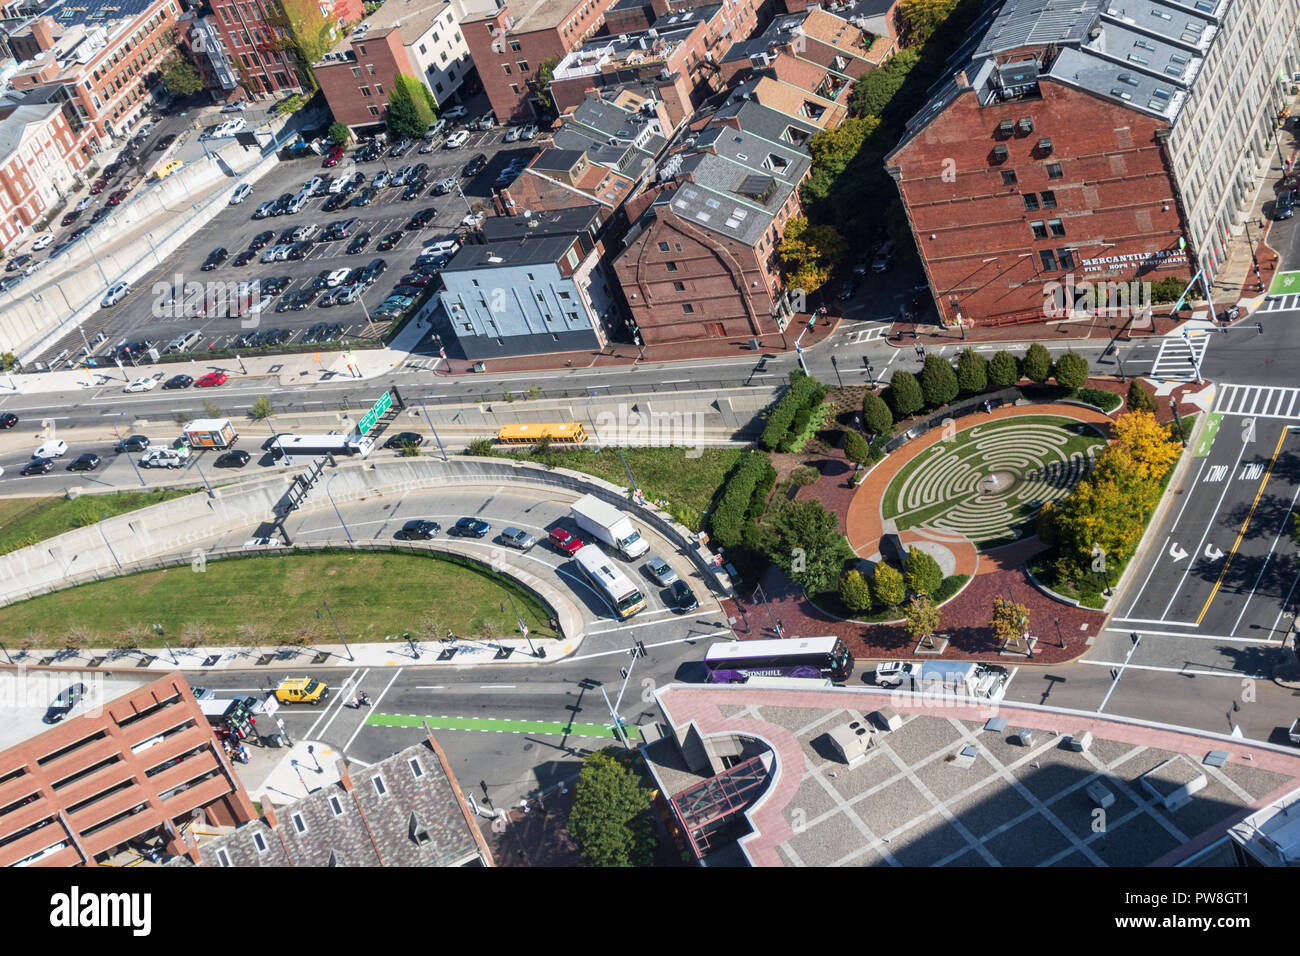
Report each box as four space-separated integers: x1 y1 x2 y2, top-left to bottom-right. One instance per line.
0 672 257 866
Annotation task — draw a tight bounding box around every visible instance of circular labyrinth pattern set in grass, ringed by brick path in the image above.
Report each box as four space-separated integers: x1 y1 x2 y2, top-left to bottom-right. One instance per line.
881 415 1105 545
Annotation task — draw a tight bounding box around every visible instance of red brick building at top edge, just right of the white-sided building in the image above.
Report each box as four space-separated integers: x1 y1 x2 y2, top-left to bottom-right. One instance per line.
460 0 614 122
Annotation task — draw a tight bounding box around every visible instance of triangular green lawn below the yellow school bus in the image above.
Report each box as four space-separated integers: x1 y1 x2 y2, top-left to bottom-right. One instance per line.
510 446 745 531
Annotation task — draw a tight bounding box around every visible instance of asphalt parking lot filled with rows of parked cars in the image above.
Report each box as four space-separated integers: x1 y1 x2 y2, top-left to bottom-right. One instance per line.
30 121 534 364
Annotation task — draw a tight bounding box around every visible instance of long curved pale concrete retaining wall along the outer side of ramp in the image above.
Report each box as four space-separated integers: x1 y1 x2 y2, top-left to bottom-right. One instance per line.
0 458 732 606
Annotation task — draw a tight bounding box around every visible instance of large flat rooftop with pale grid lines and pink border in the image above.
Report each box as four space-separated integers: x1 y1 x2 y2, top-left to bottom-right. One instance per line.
647 684 1300 866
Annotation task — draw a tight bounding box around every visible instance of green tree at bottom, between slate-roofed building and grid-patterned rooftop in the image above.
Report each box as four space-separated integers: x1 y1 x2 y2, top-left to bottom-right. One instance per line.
568 748 655 866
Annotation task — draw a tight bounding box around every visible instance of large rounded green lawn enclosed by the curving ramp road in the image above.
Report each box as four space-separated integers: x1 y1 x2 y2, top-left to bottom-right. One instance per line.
0 551 555 648
